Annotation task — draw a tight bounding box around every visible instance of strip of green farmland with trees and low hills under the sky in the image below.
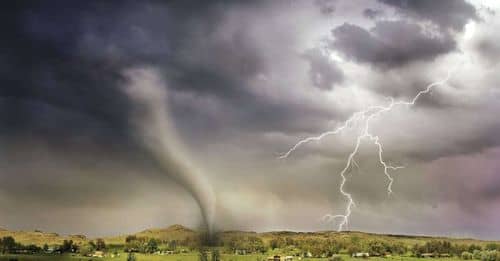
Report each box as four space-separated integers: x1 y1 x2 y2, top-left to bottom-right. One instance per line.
0 225 500 261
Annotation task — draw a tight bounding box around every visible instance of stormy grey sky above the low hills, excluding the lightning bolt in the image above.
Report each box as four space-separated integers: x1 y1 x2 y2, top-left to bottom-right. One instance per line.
0 0 500 239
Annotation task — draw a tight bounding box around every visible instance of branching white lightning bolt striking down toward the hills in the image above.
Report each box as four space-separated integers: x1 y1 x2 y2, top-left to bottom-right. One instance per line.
278 66 458 231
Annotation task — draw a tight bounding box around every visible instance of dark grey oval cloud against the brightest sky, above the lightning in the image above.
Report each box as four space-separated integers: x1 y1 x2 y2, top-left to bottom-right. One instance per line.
332 21 456 69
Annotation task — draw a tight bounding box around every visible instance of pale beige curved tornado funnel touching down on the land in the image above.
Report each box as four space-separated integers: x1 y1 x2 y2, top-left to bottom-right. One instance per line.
123 68 216 235
